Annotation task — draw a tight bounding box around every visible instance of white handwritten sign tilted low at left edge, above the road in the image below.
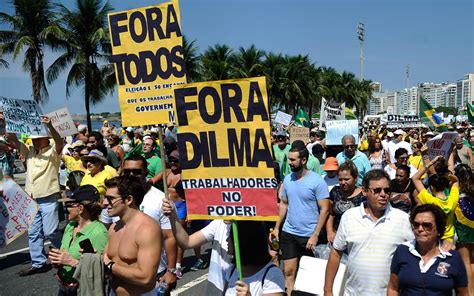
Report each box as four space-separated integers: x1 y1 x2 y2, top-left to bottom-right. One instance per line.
0 179 39 248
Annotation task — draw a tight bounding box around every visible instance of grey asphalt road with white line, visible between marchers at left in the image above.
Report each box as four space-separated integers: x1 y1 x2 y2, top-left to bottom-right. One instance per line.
0 170 211 296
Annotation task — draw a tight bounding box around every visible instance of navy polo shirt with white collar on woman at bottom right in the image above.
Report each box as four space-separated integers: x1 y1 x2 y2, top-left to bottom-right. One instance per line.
390 241 467 296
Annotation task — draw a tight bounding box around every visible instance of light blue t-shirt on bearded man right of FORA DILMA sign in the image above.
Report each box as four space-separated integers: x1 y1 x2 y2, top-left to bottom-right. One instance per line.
282 171 329 237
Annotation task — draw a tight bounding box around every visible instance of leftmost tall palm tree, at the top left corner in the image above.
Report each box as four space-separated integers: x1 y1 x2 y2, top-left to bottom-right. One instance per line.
0 0 61 103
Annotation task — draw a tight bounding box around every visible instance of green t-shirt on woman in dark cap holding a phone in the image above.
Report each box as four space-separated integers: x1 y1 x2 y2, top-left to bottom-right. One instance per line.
58 220 109 282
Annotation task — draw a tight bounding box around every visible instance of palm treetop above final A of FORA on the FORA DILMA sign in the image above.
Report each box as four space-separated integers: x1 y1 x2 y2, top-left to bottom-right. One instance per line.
234 45 265 78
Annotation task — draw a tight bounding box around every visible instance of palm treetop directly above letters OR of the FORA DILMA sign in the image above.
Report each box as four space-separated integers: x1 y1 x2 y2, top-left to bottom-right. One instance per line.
201 44 235 81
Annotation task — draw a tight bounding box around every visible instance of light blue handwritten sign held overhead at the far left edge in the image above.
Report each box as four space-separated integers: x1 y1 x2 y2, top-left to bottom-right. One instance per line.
0 97 49 136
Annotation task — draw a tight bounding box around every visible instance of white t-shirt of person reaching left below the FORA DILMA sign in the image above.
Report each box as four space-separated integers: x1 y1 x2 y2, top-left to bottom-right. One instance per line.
200 220 231 291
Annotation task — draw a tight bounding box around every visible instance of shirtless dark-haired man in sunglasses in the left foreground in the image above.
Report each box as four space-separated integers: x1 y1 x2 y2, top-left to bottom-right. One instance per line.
103 176 161 296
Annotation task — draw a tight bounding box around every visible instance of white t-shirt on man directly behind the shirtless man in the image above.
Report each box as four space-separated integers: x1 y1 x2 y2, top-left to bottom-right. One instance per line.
140 186 171 273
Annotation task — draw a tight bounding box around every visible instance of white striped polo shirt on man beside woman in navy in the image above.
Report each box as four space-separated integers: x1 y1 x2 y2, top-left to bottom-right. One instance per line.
333 202 414 296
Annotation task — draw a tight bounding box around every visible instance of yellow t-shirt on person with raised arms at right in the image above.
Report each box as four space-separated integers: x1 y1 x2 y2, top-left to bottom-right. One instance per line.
418 186 459 242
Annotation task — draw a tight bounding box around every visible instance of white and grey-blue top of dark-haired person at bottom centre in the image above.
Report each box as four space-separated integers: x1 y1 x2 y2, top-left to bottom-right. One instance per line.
225 262 285 296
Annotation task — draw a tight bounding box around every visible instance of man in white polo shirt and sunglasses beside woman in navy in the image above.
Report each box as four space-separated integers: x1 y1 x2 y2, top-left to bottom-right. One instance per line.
324 170 414 296
